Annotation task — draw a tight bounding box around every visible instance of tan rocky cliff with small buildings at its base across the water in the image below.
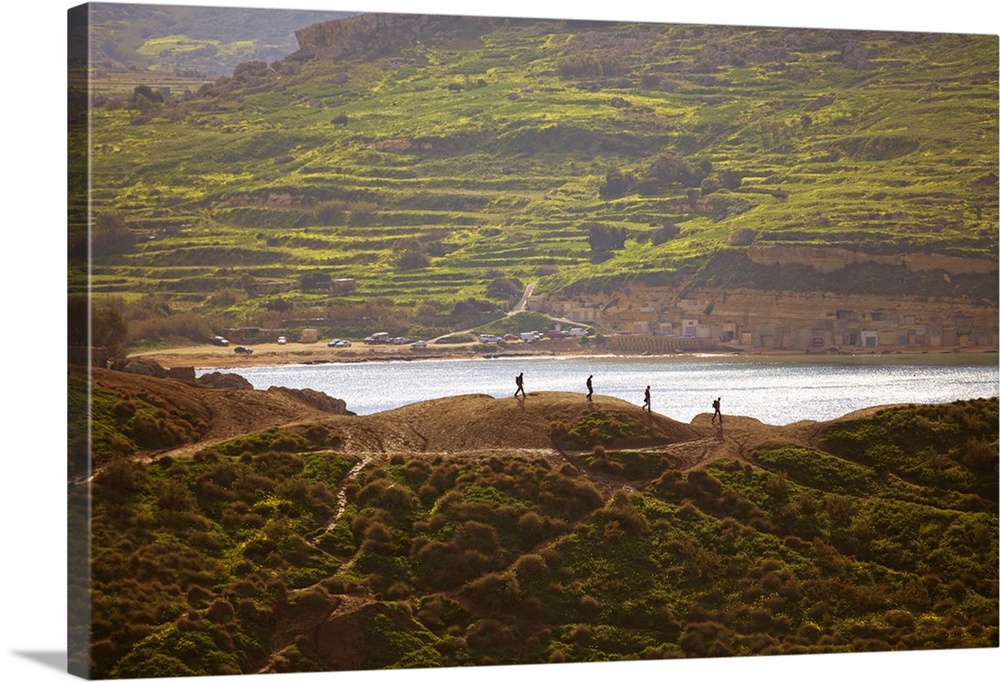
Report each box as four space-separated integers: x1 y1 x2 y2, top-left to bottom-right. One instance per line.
529 285 998 350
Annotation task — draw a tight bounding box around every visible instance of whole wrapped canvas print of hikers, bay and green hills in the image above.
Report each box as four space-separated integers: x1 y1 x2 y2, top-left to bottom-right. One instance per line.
67 3 998 679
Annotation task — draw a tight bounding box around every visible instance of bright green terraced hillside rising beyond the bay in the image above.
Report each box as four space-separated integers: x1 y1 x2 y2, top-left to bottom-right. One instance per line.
70 15 998 344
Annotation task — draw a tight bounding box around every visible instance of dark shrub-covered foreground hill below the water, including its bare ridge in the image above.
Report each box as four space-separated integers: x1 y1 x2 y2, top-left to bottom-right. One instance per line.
70 364 998 678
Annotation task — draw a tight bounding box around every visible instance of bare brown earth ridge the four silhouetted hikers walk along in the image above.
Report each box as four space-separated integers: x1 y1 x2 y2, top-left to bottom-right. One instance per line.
70 368 912 468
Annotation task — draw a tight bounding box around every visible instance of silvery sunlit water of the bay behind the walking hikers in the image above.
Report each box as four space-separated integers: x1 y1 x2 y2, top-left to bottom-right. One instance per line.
198 354 998 424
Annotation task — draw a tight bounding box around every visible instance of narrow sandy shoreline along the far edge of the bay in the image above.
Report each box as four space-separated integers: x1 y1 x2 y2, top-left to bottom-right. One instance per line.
126 340 997 371
